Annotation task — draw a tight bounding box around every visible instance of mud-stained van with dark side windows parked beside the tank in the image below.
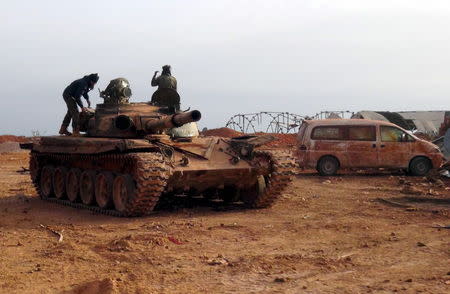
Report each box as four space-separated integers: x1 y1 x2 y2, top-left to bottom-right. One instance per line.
297 119 443 176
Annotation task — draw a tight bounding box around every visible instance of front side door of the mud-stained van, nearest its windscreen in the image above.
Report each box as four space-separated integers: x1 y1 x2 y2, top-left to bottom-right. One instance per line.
378 125 415 168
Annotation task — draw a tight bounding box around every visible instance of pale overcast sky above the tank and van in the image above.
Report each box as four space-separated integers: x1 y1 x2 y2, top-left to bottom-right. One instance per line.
0 0 450 135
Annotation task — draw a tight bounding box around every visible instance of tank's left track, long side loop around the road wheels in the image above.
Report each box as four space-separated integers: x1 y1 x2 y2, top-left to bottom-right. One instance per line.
30 152 171 217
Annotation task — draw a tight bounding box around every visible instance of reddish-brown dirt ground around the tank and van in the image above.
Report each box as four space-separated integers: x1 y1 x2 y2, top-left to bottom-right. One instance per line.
0 152 450 293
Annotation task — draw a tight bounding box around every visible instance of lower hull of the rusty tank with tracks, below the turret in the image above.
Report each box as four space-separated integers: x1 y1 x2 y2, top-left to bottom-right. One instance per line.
30 135 295 216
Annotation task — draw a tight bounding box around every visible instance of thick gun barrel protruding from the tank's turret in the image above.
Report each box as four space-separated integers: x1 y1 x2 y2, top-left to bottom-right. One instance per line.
144 110 202 133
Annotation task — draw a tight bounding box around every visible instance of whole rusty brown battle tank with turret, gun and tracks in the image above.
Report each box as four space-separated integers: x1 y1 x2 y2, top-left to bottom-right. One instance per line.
22 78 295 216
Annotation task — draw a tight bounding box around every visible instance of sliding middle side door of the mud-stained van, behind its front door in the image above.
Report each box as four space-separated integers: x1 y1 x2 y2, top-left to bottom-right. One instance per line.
347 125 379 167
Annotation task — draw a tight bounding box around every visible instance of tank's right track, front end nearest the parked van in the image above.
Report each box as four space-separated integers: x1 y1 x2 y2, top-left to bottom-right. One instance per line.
250 150 297 208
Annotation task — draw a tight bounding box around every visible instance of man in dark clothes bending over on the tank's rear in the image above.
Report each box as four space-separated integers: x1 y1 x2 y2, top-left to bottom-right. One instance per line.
59 73 99 136
